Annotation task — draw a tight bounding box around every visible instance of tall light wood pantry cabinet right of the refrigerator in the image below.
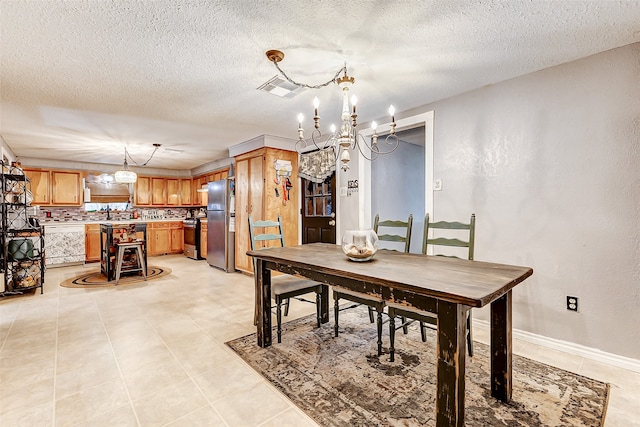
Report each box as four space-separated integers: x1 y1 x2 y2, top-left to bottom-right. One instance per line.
235 148 299 273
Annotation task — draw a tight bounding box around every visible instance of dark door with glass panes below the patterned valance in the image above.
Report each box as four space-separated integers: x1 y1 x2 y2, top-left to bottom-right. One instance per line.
302 171 336 245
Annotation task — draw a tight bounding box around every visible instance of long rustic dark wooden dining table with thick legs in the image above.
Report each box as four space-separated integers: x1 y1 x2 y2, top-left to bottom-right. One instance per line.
247 243 533 427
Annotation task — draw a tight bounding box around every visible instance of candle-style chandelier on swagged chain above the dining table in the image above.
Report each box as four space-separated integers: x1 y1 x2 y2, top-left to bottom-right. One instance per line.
267 50 400 171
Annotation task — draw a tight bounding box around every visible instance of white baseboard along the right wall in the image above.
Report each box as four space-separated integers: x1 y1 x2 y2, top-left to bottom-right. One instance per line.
473 319 640 372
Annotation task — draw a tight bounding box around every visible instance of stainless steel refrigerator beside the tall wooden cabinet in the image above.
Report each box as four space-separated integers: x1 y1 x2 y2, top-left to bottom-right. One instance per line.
207 179 236 272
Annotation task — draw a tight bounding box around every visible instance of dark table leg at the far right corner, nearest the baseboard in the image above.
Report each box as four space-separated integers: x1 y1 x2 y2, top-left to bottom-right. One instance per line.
491 291 513 402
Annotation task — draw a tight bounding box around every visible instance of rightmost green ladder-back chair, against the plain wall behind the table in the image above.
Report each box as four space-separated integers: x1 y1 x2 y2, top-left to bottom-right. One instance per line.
387 214 476 362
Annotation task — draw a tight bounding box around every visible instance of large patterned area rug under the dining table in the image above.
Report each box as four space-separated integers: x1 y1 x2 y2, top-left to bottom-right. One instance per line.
226 309 609 427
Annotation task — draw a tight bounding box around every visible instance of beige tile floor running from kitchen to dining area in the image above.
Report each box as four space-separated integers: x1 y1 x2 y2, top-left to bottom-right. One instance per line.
0 255 640 427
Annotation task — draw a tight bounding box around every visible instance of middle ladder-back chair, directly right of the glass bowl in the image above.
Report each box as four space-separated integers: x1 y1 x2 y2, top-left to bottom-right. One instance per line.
333 214 413 356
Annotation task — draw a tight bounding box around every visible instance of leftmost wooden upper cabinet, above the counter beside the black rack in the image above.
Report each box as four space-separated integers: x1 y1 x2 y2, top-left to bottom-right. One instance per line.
24 168 82 206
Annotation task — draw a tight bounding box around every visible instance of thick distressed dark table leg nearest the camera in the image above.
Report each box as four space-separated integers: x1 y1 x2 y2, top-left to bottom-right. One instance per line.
436 301 467 427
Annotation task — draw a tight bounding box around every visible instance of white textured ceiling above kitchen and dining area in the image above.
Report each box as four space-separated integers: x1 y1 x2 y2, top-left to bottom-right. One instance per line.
0 0 640 169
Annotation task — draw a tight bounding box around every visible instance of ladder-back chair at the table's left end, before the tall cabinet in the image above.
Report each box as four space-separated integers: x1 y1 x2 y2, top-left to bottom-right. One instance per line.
249 215 328 343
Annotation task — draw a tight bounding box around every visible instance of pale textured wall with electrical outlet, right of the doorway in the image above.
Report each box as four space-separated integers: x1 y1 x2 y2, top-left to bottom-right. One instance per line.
339 43 640 359
